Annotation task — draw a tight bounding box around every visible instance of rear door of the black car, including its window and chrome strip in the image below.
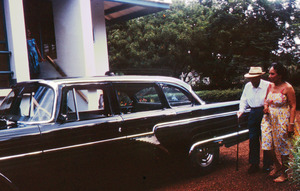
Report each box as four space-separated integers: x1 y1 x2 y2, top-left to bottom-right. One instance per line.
113 82 175 142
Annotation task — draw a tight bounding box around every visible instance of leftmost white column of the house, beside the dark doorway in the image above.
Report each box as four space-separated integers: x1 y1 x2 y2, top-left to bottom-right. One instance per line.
4 0 30 82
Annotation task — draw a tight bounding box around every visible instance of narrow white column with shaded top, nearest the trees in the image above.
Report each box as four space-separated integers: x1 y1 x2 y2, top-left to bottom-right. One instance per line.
91 0 109 75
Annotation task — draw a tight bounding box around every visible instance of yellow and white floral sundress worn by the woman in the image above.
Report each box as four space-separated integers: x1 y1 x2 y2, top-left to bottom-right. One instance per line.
261 91 299 155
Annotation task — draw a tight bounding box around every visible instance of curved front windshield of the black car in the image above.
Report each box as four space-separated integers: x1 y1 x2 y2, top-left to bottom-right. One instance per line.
0 84 54 122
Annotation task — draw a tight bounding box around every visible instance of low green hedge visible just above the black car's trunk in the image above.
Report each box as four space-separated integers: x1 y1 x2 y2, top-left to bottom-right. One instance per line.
196 89 243 103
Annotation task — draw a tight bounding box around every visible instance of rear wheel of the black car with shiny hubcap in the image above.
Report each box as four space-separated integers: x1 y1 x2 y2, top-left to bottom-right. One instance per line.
190 147 219 172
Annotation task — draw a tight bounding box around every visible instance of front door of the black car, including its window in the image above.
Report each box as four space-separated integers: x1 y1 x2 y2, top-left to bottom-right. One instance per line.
41 83 125 162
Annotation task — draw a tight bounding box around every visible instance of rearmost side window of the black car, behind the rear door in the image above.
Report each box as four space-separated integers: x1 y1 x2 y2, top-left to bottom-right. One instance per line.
161 84 193 107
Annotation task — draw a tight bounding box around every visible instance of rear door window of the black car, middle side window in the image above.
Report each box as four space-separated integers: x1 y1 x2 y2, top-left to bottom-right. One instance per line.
114 83 162 114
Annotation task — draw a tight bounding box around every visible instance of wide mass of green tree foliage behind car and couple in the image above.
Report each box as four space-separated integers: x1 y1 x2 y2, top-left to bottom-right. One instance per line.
107 0 300 87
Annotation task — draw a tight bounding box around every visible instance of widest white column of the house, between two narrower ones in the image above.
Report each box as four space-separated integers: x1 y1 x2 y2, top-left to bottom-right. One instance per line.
53 0 96 77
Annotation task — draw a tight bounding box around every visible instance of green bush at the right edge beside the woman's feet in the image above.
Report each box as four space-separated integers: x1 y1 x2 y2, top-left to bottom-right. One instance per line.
288 137 300 188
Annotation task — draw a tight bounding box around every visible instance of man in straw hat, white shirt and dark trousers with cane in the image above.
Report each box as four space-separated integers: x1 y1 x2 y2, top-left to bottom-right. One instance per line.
237 67 272 174
